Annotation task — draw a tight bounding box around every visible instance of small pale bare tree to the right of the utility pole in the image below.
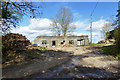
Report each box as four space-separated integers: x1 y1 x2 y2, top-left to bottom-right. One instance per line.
102 22 112 40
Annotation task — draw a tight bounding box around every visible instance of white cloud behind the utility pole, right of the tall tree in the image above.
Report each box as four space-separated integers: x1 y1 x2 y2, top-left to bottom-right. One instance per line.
77 18 109 43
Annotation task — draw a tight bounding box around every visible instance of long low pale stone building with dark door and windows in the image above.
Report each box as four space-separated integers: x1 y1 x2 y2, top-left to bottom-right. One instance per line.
34 36 89 47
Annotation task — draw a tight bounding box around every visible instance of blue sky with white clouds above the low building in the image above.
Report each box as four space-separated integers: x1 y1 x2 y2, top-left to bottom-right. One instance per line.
11 2 118 43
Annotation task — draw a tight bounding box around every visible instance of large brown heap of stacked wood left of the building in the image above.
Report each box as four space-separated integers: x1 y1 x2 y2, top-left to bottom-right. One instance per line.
2 33 30 53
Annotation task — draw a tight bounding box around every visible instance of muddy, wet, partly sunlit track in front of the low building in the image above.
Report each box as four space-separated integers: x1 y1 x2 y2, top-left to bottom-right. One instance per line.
3 47 120 78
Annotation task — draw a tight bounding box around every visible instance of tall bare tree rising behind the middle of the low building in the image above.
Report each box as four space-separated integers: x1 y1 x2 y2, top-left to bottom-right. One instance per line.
52 8 75 36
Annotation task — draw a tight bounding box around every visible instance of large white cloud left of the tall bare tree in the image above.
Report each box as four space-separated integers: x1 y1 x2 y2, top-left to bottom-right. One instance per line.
11 18 52 41
